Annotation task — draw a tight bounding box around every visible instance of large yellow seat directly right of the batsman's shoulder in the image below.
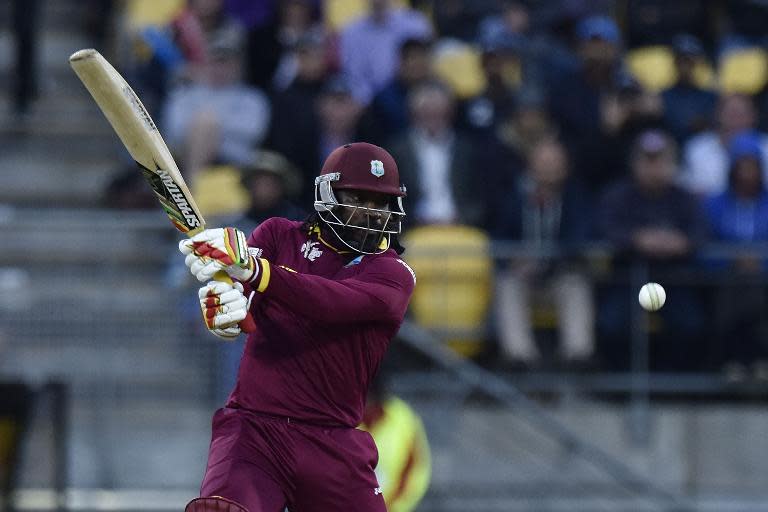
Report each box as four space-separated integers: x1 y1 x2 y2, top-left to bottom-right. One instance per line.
403 225 493 356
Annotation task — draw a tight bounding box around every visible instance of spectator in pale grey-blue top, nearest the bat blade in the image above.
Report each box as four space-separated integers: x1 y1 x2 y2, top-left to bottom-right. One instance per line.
163 40 270 177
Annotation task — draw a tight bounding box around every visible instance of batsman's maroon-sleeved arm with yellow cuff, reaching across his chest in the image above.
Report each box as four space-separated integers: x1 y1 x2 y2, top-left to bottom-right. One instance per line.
246 258 415 323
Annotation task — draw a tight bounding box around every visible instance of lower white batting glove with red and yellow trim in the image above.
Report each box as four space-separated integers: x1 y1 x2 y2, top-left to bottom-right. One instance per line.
197 281 250 339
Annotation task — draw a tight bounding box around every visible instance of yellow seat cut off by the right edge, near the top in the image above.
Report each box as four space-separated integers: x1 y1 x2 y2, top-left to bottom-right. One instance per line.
718 48 768 95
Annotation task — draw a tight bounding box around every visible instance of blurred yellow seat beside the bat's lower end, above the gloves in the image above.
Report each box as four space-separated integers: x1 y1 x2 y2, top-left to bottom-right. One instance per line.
192 165 250 217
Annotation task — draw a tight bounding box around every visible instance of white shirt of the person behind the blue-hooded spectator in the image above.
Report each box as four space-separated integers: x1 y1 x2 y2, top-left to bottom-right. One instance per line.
680 131 768 196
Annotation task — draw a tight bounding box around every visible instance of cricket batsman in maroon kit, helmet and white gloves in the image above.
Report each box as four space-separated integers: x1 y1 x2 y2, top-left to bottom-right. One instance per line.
179 142 416 512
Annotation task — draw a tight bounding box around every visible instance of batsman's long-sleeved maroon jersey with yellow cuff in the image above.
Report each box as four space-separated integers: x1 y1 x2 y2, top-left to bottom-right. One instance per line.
227 218 416 427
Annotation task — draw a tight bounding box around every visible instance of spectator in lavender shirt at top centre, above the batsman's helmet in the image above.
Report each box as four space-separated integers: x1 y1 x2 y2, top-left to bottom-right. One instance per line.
339 0 432 105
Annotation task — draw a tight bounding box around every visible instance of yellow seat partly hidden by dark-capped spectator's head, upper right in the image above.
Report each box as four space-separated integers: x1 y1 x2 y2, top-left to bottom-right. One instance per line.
625 46 715 92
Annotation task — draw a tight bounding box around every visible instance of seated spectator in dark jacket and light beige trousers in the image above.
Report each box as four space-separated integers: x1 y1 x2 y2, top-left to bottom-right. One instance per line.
492 138 594 368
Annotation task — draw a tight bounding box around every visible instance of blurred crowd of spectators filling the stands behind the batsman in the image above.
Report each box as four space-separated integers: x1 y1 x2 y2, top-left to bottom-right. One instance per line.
110 0 768 378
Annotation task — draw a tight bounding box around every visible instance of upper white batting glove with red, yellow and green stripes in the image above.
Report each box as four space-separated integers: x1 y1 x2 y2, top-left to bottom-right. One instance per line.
179 228 259 283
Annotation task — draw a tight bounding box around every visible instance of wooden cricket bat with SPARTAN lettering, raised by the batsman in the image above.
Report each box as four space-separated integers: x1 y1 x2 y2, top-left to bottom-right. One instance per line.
69 49 256 332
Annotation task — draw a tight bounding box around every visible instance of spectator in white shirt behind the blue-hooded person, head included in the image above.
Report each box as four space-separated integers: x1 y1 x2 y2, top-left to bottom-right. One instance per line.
681 94 768 196
